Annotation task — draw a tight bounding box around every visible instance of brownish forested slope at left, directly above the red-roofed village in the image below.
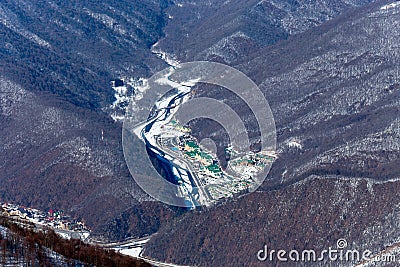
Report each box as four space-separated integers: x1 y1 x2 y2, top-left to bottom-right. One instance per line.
0 79 178 239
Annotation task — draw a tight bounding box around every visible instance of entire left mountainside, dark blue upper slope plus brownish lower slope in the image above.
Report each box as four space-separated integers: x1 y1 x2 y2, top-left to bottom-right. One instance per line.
0 1 175 238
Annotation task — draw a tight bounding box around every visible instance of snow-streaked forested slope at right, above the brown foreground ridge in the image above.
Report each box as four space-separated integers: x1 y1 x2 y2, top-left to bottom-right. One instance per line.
245 1 400 188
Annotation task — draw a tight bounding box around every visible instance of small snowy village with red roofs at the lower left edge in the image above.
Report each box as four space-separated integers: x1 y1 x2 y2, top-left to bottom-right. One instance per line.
0 202 90 240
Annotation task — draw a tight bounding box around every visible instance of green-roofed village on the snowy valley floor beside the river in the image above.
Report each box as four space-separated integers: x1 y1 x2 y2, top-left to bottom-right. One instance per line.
157 119 276 200
